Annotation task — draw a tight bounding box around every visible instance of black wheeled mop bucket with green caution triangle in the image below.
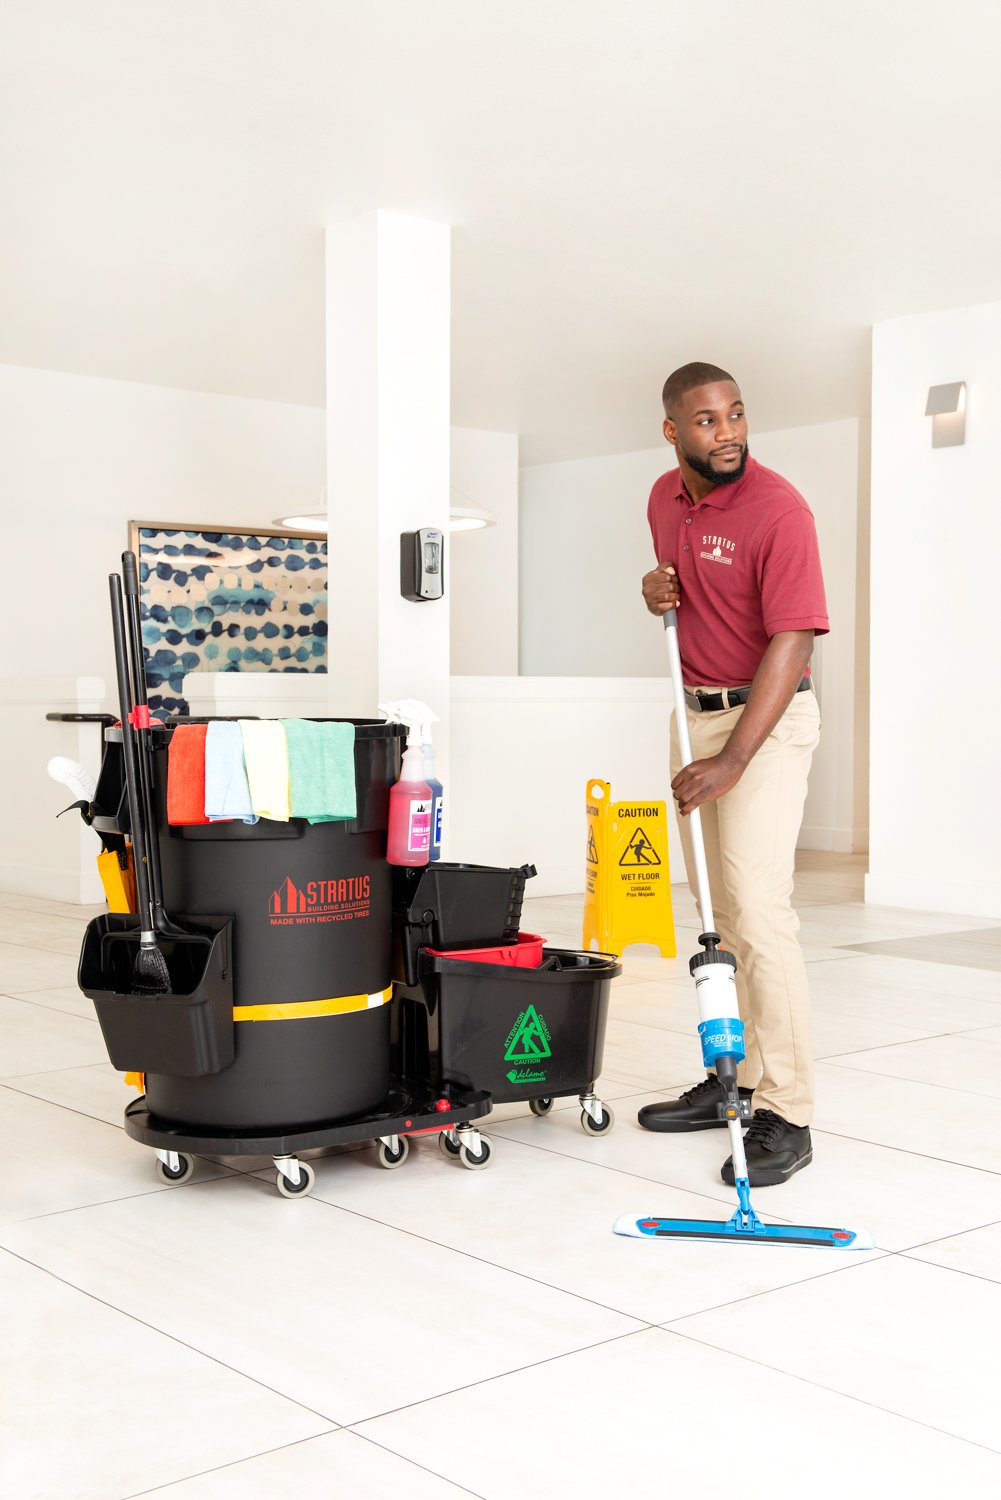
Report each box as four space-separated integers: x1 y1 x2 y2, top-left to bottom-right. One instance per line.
408 948 623 1104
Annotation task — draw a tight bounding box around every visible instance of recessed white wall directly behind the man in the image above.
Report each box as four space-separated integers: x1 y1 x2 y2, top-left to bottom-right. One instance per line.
521 420 866 851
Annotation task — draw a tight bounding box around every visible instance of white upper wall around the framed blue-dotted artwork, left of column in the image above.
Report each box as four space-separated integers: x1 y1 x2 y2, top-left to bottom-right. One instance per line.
0 366 324 689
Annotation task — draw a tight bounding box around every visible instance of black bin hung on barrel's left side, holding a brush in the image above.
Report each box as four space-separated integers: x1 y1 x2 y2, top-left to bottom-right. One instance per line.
78 914 234 1079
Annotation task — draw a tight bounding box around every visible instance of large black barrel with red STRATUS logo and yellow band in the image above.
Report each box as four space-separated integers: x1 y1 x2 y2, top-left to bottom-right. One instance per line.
146 720 405 1133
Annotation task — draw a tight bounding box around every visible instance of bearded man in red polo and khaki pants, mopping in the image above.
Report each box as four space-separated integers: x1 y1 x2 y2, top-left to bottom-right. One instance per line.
639 363 828 1185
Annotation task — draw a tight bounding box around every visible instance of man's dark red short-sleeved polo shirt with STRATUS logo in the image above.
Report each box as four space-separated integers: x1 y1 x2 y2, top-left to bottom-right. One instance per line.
647 458 830 687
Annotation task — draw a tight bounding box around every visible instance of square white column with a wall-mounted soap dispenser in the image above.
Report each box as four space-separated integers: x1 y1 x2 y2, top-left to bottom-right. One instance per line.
327 210 450 798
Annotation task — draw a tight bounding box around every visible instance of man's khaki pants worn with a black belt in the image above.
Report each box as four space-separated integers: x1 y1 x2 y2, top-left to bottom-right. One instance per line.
671 687 821 1125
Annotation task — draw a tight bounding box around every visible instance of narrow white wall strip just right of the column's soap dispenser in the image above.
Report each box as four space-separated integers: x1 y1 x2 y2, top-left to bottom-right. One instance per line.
446 428 518 677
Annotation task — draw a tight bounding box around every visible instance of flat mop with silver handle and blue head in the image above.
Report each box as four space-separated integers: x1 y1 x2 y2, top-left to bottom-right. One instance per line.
612 609 875 1250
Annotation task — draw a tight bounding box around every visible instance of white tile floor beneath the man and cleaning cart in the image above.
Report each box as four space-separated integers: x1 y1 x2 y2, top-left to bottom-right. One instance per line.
0 858 1001 1500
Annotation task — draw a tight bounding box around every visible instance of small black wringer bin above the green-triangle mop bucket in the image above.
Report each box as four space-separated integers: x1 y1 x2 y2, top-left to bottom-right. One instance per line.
393 861 536 986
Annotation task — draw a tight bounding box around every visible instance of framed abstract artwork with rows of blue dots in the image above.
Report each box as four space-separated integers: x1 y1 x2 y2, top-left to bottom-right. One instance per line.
129 521 327 714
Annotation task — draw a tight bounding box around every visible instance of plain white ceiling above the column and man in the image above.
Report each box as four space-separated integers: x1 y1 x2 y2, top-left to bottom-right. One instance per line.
0 0 1001 462
